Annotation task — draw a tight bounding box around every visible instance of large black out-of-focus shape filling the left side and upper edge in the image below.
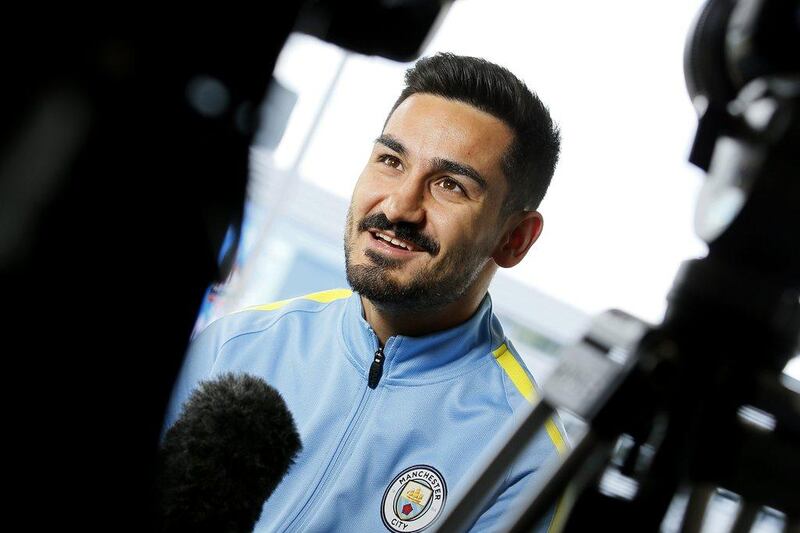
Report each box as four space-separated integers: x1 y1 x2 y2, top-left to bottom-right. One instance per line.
0 2 442 531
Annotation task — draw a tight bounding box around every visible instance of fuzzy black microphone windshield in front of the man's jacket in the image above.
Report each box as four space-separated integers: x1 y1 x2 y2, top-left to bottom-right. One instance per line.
157 374 302 533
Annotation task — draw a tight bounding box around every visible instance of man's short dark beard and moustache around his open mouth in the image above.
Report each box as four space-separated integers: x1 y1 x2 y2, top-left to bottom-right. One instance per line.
344 209 487 311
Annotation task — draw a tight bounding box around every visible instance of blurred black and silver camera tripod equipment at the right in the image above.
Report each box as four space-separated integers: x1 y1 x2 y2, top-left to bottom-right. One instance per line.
439 0 800 532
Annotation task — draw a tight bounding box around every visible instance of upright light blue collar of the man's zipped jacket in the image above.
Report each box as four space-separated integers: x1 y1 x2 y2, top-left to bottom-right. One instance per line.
342 292 504 385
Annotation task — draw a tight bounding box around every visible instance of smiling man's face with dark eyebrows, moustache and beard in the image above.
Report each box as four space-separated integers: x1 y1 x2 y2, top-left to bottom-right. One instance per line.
345 94 513 310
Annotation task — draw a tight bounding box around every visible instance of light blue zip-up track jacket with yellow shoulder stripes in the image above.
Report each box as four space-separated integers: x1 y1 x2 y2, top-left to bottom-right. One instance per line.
165 289 564 533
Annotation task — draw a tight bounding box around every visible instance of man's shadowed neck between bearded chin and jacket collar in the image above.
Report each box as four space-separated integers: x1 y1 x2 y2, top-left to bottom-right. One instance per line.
361 290 486 346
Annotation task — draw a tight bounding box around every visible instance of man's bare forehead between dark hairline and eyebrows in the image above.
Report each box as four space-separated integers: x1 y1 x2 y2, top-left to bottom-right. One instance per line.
384 93 514 184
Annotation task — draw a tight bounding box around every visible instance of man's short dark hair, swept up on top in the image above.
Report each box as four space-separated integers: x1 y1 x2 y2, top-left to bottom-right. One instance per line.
387 53 560 214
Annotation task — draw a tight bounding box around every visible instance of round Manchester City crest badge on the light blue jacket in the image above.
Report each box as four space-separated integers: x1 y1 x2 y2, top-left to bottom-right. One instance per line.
381 465 447 532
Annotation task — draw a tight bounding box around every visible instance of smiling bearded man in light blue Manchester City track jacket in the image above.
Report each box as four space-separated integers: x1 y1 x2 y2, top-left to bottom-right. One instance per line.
162 54 564 532
